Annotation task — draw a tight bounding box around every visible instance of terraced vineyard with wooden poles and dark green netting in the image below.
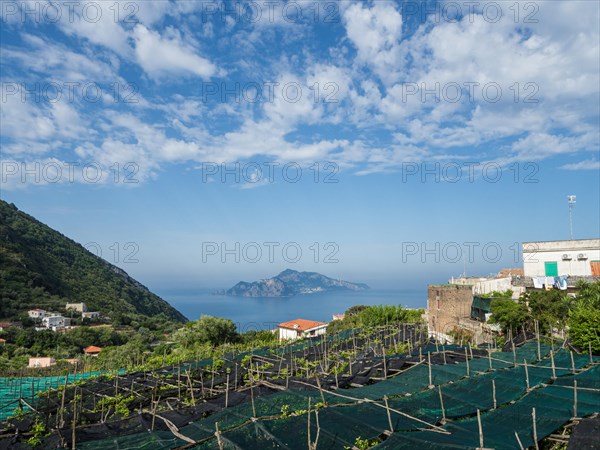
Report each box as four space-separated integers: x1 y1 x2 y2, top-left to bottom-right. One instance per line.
0 324 600 450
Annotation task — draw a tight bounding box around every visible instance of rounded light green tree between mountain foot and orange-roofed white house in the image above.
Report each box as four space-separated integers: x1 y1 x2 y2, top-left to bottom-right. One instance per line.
173 316 239 348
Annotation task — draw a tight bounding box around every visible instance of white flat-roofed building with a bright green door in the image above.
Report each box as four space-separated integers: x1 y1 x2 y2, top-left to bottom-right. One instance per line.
523 239 600 277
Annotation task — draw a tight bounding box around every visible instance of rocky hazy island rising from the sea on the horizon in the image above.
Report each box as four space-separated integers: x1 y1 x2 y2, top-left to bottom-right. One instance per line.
227 269 369 297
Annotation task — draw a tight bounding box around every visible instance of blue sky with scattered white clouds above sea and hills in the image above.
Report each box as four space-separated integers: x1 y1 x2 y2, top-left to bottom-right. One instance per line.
0 0 600 292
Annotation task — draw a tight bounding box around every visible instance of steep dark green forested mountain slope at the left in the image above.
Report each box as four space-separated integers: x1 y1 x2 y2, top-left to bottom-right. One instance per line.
0 200 187 324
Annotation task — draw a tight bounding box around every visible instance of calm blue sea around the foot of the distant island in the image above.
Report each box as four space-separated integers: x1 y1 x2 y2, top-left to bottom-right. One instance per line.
159 288 427 333
